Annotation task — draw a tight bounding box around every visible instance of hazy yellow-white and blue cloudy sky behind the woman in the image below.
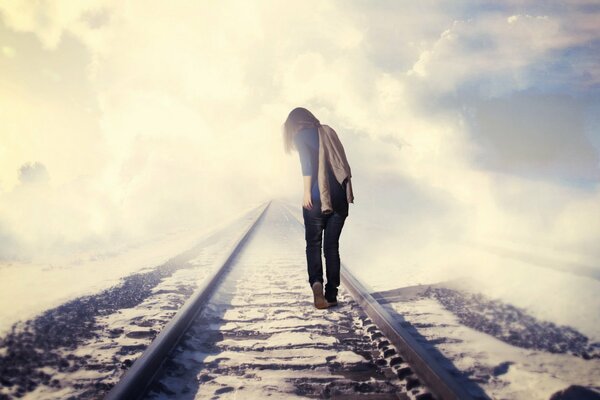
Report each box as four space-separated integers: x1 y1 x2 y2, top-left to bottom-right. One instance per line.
0 1 600 270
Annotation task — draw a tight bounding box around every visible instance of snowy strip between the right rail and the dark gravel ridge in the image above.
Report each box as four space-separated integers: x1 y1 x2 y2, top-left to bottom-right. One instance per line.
380 288 600 400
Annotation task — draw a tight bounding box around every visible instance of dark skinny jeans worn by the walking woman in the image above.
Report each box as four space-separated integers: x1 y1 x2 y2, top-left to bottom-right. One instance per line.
302 199 347 300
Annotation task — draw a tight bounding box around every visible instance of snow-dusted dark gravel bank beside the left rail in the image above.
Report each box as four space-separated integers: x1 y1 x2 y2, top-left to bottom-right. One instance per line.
0 204 264 398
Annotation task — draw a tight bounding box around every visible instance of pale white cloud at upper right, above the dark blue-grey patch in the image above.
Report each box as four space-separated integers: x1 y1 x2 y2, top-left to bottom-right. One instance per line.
408 13 599 96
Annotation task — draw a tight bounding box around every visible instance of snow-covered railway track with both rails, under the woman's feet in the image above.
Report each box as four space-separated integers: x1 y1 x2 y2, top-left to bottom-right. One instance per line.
106 201 482 400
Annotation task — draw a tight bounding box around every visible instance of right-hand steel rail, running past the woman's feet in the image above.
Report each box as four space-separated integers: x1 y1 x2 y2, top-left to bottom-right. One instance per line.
278 205 476 400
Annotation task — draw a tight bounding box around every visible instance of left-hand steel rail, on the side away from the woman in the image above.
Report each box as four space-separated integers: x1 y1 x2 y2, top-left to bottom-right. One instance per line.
105 201 272 400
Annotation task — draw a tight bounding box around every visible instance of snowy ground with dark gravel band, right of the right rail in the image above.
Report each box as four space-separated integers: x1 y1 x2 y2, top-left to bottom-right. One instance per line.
286 201 600 399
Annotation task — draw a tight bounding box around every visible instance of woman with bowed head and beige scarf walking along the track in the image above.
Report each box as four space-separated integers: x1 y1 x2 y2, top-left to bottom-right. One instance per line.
283 107 353 309
